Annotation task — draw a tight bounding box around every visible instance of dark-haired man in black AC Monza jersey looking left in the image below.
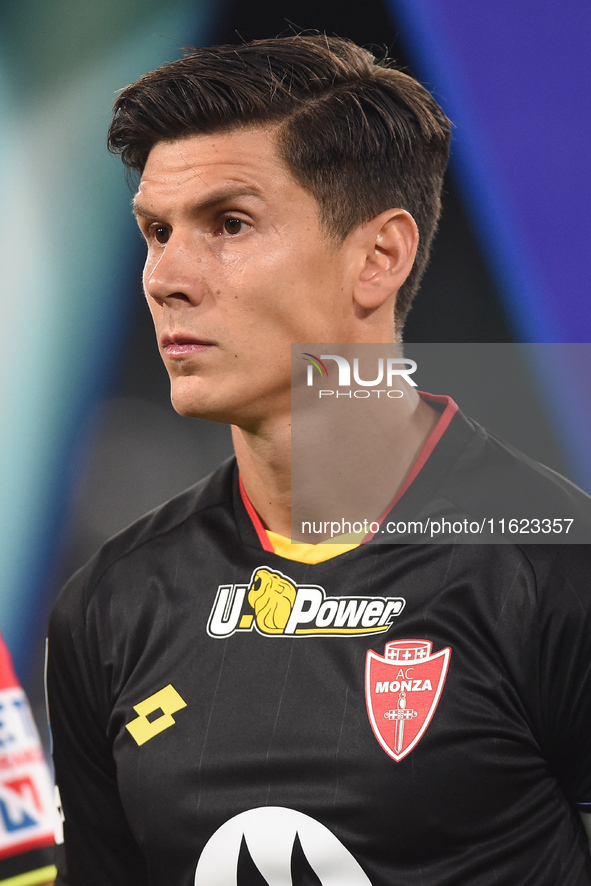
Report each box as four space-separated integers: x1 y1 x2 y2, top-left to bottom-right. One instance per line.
48 36 591 886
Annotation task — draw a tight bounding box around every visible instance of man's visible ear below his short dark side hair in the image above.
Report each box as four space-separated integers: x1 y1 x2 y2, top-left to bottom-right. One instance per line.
353 209 419 311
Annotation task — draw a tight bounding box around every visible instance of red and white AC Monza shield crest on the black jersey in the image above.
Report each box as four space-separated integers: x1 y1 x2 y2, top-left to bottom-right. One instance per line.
365 640 451 762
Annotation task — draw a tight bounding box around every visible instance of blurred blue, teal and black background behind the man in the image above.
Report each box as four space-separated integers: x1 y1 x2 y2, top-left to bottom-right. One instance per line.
0 0 591 744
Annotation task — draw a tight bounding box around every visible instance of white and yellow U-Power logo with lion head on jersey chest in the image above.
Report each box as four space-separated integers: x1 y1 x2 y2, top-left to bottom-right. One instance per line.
207 566 405 637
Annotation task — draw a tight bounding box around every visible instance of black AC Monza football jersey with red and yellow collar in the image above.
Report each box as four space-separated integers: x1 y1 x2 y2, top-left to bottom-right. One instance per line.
48 414 591 886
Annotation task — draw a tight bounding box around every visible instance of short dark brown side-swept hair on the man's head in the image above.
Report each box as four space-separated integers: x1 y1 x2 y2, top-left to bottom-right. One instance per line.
108 35 450 325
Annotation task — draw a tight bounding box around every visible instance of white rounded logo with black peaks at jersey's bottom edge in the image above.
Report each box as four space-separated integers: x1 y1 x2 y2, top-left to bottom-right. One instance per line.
195 806 371 886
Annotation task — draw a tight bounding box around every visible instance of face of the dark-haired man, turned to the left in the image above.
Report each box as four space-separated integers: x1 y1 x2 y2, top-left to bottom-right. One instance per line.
135 128 353 427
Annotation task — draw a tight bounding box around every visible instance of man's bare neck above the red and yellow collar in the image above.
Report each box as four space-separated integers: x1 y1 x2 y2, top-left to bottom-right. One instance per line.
232 389 439 542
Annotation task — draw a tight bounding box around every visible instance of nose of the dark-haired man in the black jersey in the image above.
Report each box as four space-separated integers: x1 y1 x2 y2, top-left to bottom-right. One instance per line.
143 233 207 307
